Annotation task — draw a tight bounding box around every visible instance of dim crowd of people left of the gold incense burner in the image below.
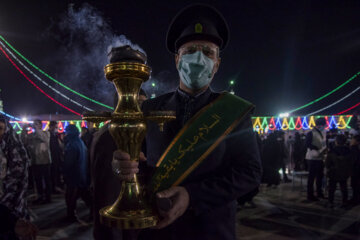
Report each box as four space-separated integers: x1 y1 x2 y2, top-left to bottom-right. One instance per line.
0 116 92 239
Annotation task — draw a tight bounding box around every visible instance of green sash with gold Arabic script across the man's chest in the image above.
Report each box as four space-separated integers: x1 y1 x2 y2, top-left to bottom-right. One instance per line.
150 92 254 193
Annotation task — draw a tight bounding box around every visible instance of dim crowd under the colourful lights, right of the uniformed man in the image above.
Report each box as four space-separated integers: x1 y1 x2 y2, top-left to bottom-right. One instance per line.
258 116 360 208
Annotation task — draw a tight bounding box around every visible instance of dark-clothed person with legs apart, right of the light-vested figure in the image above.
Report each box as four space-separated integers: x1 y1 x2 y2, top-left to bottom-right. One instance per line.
325 135 352 208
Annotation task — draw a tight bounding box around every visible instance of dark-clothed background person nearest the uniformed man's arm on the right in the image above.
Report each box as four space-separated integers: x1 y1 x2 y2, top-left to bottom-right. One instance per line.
262 133 282 187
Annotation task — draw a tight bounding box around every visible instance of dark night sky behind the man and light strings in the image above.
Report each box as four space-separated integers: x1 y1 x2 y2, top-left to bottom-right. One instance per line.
0 0 360 116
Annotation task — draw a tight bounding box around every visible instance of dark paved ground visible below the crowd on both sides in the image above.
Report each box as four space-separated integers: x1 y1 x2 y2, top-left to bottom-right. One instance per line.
31 177 360 240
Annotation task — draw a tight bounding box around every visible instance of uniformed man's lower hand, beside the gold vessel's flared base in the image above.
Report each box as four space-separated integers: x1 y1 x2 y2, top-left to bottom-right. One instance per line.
155 187 190 229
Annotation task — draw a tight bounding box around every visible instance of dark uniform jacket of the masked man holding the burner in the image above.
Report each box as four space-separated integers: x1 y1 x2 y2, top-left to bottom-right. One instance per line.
139 88 261 240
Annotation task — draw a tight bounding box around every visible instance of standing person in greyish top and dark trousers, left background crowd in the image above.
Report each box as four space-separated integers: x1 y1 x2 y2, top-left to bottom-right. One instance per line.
29 119 51 204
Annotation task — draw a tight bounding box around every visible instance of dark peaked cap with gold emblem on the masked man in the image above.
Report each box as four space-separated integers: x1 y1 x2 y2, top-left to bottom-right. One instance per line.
166 4 229 53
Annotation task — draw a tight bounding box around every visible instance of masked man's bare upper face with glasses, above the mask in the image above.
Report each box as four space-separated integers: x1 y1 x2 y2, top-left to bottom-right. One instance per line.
175 40 221 77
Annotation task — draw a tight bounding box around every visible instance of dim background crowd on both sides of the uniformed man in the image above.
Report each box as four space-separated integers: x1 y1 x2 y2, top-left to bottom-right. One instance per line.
0 111 360 239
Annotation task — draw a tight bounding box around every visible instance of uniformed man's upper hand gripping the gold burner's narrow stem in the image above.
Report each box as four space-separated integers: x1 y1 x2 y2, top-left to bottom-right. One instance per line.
111 150 146 181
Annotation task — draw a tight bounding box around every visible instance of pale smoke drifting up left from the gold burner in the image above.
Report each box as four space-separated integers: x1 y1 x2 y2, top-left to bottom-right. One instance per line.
45 3 146 109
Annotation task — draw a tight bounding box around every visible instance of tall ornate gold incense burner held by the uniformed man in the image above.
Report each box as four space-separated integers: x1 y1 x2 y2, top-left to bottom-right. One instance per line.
84 46 175 229
